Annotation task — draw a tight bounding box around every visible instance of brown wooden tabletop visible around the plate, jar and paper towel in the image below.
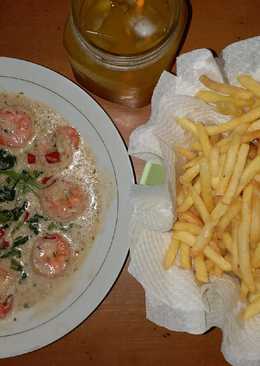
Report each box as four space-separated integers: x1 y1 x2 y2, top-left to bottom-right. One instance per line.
0 0 260 366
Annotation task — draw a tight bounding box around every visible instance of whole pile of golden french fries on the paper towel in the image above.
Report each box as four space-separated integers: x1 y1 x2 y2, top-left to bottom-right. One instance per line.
163 75 260 320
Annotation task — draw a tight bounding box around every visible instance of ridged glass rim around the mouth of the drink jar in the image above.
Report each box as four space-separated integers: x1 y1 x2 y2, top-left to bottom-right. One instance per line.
70 0 184 67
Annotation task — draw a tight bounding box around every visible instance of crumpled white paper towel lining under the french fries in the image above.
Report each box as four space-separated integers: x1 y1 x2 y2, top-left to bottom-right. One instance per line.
129 37 260 366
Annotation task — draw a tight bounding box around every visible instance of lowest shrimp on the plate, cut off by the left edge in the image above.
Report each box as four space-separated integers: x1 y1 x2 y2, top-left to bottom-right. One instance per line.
0 267 16 319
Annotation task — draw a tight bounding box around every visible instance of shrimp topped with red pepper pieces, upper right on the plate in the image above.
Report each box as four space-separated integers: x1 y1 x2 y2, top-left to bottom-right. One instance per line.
31 126 80 173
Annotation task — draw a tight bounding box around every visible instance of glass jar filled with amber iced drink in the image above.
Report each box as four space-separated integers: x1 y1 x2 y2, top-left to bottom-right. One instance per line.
64 0 187 107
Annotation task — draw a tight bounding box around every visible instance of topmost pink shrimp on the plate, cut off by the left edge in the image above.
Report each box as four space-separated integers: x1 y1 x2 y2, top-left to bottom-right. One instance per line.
0 108 33 148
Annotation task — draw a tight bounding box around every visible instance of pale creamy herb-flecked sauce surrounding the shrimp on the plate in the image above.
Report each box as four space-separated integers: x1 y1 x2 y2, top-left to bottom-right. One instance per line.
0 93 103 311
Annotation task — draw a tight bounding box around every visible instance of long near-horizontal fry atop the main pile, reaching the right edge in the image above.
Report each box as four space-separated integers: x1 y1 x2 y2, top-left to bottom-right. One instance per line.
206 107 260 136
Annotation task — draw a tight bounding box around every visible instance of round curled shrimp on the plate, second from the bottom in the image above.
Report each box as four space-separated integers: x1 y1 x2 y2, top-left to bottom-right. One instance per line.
32 233 71 278
